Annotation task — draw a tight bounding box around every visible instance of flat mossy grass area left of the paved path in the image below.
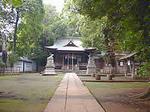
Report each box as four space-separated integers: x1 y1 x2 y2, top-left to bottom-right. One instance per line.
0 74 63 112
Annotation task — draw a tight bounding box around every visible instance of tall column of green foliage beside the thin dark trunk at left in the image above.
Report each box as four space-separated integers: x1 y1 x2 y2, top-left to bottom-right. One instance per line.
13 0 44 56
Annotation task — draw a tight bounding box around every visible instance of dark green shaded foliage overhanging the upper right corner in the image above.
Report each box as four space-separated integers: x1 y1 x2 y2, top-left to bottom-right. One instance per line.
71 0 150 97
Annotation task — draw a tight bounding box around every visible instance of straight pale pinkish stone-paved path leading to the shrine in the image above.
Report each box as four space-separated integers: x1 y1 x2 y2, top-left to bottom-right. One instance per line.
44 73 105 112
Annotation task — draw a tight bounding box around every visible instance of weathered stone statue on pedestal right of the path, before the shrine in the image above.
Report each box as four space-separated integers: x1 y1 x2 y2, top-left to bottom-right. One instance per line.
86 55 96 76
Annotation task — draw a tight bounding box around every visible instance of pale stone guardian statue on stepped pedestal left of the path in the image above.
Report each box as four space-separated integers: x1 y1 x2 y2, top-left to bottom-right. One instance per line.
43 54 56 75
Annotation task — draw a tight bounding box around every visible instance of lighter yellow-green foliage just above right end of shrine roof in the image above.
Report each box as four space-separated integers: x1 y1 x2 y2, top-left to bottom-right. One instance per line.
79 17 107 51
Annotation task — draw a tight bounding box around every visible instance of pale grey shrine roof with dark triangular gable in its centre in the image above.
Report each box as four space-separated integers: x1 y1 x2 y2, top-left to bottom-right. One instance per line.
46 37 86 51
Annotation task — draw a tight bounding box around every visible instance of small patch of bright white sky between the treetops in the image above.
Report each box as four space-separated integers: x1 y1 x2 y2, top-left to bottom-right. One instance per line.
43 0 64 12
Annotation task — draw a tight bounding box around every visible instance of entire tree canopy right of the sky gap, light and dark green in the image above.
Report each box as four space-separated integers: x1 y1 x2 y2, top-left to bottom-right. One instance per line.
61 0 150 76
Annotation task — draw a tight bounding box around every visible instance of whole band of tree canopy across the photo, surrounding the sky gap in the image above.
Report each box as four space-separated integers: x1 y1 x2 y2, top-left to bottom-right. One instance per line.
0 0 150 74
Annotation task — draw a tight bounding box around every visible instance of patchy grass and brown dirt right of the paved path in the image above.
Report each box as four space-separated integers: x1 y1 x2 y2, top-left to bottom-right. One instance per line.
84 82 150 112
